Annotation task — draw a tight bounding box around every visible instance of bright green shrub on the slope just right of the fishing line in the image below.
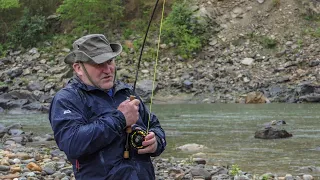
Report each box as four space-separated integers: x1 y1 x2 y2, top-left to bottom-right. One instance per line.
162 3 208 58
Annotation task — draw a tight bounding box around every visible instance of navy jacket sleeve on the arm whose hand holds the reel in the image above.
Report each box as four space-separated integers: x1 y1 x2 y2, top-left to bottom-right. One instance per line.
140 99 167 157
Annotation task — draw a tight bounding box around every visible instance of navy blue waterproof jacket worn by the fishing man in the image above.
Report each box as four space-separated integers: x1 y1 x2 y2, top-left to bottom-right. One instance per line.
49 77 166 180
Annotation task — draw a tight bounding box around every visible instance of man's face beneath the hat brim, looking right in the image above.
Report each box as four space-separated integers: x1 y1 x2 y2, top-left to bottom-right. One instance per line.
73 59 116 90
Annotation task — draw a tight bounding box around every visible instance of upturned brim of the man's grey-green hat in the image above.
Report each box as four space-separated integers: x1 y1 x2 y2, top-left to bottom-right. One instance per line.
64 43 122 64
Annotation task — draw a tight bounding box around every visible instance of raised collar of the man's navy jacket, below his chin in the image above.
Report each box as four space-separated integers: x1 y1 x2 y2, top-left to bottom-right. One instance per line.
68 76 133 94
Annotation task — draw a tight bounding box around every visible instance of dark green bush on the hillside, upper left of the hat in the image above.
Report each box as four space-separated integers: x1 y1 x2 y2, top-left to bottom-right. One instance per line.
8 9 47 48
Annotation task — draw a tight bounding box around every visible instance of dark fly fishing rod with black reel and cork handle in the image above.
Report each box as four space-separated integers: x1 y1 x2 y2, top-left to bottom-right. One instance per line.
123 0 163 159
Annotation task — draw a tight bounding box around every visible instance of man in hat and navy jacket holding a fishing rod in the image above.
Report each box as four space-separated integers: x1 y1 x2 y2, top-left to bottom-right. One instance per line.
49 34 166 180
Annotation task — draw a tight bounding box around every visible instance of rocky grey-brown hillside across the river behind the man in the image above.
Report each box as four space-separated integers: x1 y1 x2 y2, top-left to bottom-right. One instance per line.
0 0 320 111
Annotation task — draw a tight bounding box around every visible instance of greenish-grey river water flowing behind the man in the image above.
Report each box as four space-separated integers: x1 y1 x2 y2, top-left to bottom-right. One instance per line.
0 104 320 176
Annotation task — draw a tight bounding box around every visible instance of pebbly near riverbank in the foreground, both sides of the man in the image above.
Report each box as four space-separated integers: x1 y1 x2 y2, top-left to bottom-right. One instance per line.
0 124 320 180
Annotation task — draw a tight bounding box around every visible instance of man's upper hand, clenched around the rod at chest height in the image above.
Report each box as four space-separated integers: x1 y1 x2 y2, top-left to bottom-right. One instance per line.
118 99 140 127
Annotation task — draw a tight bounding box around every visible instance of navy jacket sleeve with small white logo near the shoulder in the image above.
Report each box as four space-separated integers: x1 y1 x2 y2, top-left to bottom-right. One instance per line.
49 89 126 159
